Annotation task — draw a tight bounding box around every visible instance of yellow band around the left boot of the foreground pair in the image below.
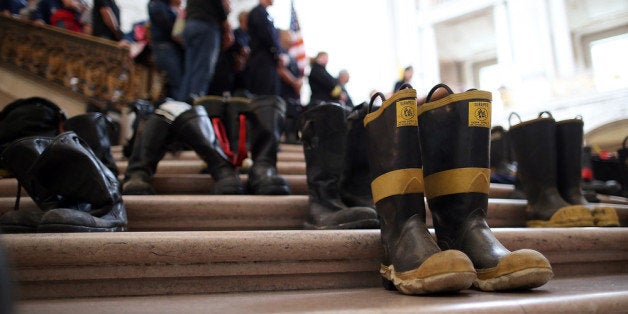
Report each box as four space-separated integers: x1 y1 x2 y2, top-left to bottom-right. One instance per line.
371 168 424 202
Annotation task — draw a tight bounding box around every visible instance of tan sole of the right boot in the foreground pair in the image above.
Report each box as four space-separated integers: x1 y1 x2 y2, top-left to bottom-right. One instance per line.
473 268 554 291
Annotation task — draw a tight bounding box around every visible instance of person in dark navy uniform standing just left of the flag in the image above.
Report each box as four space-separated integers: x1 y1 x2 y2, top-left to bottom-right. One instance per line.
246 0 283 95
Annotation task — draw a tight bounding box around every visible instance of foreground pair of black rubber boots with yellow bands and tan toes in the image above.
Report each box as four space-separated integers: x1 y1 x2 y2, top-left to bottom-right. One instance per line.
364 84 553 294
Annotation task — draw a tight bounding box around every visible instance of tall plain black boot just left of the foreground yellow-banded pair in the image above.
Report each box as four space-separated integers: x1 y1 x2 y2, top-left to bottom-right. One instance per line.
301 103 379 229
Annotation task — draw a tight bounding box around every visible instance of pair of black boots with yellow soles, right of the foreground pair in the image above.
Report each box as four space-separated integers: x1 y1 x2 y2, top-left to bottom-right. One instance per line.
508 111 619 227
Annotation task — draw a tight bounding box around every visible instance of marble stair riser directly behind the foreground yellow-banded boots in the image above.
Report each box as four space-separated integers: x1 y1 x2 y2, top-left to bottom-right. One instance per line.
0 228 628 299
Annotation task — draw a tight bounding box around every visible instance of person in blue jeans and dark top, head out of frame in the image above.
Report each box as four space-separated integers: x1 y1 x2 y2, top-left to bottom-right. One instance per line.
179 0 233 101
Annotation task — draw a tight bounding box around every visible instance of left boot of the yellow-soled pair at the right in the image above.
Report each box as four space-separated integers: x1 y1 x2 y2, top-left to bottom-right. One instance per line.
508 112 595 227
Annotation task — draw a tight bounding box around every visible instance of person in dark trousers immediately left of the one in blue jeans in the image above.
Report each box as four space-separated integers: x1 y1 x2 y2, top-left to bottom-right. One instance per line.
148 0 184 99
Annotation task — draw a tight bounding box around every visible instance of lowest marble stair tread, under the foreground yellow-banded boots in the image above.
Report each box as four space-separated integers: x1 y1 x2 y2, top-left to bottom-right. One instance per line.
16 274 628 314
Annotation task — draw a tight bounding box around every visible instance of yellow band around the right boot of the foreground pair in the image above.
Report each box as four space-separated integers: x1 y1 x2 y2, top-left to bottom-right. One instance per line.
425 168 491 199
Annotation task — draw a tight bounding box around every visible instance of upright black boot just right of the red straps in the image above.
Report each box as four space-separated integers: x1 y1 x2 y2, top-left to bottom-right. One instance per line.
247 96 290 195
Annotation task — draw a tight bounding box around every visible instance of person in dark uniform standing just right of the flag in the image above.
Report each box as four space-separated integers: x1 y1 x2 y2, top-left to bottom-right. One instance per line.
308 51 342 106
